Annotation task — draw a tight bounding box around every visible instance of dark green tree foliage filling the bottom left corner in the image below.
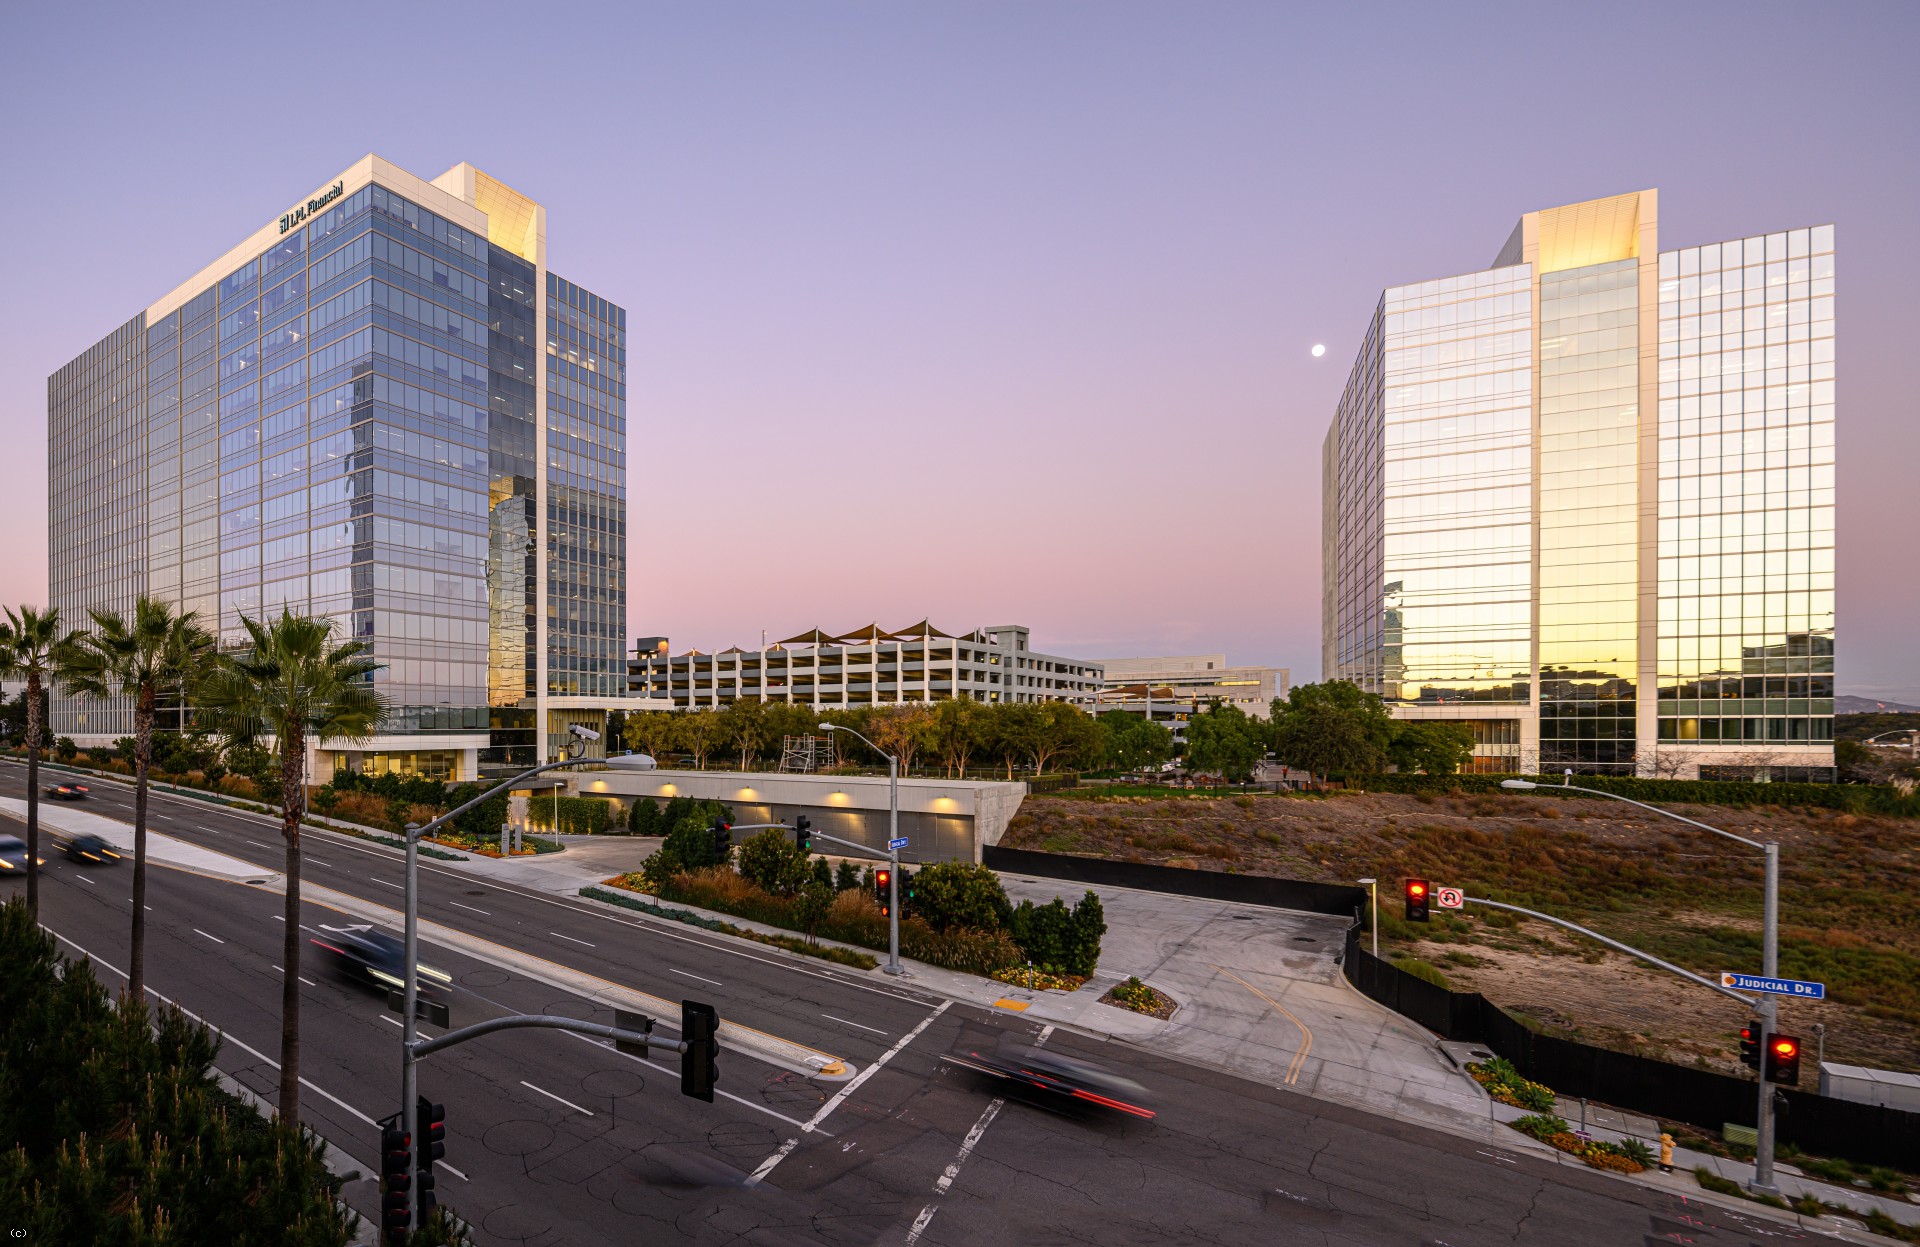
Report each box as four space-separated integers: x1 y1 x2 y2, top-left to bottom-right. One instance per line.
0 899 359 1247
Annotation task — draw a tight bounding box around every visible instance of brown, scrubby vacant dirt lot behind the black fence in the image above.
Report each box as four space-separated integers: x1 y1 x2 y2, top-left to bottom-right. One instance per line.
1002 790 1920 1086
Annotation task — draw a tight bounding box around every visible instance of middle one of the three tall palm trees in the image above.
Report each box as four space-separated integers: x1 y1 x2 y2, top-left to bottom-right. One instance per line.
60 594 213 1001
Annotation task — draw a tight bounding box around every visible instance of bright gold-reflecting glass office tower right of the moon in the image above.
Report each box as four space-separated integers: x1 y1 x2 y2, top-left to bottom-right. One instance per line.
1321 190 1834 778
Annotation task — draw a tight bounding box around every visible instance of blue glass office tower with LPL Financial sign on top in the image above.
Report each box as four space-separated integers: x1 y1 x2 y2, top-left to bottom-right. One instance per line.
48 156 626 778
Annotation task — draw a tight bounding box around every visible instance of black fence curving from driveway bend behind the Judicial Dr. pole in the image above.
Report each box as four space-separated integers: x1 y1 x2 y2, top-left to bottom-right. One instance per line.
1342 924 1920 1168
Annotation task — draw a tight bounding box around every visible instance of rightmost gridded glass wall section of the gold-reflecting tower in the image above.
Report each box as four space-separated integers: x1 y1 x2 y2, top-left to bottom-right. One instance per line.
1659 225 1836 757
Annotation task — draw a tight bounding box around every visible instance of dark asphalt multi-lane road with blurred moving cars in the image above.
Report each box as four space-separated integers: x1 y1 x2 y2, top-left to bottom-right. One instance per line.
0 763 1801 1247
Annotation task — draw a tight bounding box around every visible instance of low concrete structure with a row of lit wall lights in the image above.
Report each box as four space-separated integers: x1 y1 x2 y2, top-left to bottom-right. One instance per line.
566 770 1027 863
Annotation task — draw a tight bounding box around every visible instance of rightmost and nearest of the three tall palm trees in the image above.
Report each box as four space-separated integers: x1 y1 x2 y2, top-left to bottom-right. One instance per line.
192 609 386 1122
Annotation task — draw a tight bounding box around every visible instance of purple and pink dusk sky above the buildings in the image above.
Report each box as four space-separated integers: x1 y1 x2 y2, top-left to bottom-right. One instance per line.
0 0 1920 701
